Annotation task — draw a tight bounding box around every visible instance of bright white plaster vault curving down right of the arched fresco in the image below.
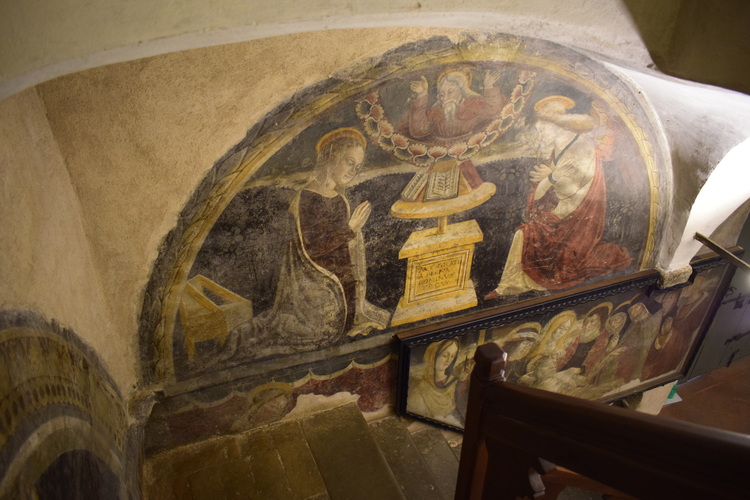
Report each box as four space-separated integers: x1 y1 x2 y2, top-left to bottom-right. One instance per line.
610 69 750 269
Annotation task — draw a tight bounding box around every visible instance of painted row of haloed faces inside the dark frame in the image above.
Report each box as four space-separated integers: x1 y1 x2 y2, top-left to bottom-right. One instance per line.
406 268 723 427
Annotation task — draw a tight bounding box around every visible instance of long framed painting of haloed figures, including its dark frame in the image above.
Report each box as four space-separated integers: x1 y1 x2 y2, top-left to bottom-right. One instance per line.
397 249 741 431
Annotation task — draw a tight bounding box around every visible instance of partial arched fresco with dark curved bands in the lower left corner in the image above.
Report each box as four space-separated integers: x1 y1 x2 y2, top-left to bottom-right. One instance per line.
0 311 129 498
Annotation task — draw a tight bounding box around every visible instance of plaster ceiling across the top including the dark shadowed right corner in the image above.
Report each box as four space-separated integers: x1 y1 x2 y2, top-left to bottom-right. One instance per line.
5 0 750 97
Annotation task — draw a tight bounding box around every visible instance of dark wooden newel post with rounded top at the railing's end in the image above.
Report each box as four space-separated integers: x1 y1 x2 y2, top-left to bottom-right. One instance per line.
455 343 507 500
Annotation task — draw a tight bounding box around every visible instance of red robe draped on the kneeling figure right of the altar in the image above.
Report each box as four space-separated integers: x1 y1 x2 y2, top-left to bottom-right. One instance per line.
519 152 633 290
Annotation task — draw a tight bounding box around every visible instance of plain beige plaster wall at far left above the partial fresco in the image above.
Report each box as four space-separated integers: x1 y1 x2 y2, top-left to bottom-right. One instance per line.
0 89 135 389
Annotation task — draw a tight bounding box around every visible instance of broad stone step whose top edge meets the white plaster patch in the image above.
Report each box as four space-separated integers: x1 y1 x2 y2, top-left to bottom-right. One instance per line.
300 404 404 500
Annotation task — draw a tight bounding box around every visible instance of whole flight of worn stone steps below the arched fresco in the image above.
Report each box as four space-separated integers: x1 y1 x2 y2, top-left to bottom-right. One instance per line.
144 403 458 500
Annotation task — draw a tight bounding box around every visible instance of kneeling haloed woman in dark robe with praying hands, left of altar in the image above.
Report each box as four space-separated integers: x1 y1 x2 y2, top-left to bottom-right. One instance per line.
225 127 390 357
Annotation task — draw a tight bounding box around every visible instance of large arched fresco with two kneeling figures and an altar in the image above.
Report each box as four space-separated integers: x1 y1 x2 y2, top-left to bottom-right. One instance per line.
140 34 671 450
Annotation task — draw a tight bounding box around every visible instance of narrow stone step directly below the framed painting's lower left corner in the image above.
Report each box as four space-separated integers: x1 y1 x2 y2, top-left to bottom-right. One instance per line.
370 417 448 500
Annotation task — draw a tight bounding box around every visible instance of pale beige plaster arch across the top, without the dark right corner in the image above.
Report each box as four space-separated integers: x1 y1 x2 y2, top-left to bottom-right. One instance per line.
0 0 656 97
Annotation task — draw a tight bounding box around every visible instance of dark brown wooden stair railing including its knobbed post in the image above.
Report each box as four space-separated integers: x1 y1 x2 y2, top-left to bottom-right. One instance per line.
455 343 750 500
